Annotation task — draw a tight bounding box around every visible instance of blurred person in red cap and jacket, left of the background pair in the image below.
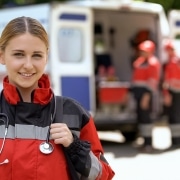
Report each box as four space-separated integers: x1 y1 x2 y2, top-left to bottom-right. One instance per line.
132 40 161 152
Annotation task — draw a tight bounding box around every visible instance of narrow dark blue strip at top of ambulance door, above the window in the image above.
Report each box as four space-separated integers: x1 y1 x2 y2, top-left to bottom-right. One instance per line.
59 13 86 21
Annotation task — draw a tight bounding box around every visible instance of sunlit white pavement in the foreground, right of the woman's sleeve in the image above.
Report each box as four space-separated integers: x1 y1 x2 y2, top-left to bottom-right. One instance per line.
105 147 180 180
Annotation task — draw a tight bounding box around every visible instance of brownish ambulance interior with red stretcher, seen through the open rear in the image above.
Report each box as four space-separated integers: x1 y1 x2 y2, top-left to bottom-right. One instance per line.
94 9 159 129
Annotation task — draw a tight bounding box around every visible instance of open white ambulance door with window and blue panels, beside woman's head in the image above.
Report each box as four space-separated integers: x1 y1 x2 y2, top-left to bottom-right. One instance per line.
50 5 95 112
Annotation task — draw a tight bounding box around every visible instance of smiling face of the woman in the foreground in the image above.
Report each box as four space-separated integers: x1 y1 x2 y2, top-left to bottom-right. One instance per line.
0 33 48 91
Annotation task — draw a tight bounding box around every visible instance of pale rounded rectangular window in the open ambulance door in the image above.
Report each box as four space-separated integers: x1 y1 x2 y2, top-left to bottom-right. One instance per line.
58 28 83 62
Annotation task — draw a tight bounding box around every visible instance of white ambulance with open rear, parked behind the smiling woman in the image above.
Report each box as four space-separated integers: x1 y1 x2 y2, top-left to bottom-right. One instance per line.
0 0 169 140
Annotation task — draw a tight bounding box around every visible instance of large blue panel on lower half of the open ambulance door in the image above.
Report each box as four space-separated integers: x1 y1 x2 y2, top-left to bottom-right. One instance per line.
61 76 90 110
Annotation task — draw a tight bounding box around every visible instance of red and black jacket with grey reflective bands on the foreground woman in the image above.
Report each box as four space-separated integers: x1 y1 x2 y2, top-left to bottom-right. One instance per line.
0 75 114 180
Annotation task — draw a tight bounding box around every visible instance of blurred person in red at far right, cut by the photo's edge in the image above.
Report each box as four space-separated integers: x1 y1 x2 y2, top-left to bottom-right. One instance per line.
163 41 180 147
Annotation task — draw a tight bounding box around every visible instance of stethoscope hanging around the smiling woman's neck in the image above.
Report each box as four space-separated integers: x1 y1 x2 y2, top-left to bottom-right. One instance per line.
0 95 56 158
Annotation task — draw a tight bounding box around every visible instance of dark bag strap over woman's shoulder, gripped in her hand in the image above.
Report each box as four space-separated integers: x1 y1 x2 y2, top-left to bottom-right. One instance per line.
55 96 80 180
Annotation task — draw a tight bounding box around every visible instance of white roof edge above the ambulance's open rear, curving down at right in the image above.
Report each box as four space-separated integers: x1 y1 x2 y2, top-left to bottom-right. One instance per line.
64 0 170 37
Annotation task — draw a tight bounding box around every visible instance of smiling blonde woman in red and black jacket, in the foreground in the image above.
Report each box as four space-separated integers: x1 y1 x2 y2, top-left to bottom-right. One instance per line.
0 17 114 180
